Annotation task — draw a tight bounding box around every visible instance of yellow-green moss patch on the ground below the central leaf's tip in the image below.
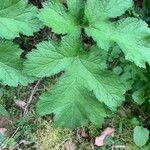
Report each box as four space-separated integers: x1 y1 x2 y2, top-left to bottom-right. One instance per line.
32 121 72 150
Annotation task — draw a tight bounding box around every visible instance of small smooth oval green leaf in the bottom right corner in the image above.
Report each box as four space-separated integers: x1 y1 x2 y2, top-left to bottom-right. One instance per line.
133 126 149 147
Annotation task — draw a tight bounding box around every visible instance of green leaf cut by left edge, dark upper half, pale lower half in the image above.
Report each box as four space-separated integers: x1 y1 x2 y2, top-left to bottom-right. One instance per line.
0 42 34 86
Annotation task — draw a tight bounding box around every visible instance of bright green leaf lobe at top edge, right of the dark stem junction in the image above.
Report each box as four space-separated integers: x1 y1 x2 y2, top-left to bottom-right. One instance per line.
85 0 133 21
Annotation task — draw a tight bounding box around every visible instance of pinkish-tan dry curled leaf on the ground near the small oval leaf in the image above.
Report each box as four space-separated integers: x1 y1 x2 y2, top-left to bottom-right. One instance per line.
95 127 115 146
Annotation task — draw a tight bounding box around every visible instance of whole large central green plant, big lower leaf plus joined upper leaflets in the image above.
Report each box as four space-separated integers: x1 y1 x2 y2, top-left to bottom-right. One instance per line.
25 0 150 128
